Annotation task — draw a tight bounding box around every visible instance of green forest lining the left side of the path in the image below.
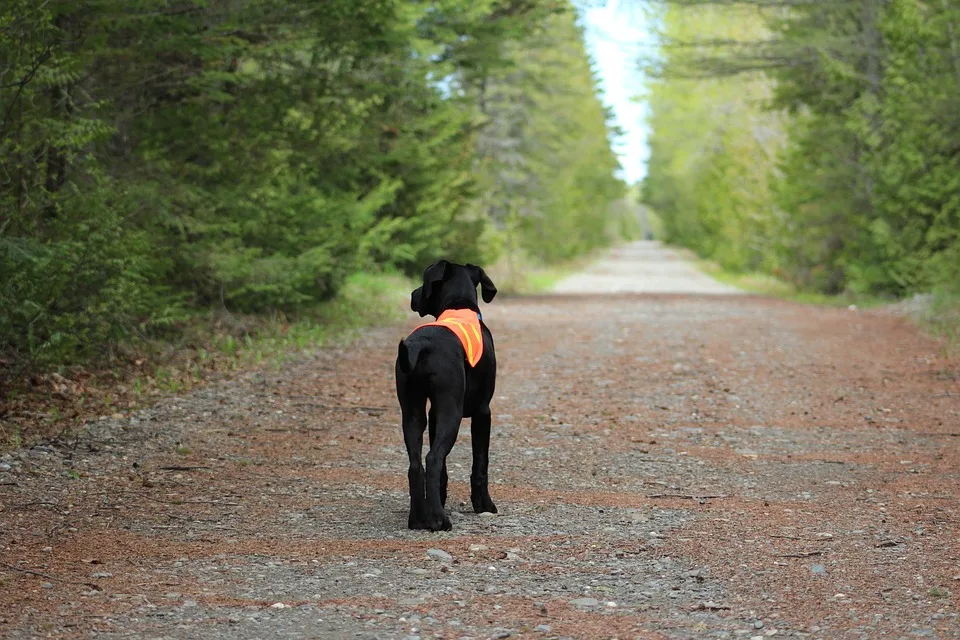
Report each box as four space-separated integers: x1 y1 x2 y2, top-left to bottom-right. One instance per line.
0 0 630 383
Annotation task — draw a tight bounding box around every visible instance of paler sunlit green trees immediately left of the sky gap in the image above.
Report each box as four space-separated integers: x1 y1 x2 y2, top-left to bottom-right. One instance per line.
470 11 626 262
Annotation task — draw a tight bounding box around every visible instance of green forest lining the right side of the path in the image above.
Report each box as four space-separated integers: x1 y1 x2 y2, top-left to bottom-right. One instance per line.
643 0 960 299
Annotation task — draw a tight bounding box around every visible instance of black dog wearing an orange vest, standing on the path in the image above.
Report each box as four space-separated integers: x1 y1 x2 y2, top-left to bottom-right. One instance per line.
396 260 497 531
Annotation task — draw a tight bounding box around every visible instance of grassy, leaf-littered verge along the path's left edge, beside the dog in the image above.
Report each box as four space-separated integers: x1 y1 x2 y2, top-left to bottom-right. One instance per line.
0 273 413 451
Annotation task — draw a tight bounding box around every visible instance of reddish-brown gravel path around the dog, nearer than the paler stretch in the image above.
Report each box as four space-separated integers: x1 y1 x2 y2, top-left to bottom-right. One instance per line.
0 246 960 639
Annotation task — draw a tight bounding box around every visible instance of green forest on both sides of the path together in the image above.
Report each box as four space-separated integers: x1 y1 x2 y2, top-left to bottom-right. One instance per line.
9 0 960 392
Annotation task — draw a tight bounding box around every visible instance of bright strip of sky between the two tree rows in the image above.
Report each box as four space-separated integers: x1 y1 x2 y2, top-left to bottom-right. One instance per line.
580 0 651 184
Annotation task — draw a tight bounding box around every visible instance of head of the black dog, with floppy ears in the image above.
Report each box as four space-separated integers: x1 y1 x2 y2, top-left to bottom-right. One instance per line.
410 260 497 317
